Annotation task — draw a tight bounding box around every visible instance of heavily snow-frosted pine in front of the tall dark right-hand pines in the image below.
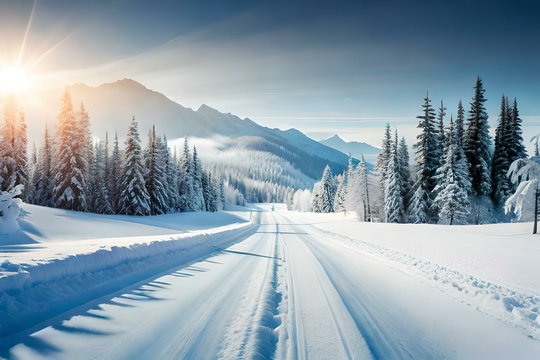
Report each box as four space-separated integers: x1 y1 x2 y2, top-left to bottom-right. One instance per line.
432 117 470 225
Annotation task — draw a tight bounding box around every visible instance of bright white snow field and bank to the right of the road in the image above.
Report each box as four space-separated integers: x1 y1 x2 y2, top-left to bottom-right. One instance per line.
296 214 540 340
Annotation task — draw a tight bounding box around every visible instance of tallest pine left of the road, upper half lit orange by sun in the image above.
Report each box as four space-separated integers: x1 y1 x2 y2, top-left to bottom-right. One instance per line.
54 89 88 211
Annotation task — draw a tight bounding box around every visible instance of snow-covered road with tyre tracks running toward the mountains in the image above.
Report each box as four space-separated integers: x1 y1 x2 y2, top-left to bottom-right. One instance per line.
0 207 540 359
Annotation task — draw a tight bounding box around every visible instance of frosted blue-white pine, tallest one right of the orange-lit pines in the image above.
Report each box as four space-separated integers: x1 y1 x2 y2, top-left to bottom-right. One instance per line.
119 116 150 215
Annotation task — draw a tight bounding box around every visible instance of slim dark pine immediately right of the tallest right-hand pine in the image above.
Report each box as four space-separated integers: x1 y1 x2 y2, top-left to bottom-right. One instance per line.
491 95 511 206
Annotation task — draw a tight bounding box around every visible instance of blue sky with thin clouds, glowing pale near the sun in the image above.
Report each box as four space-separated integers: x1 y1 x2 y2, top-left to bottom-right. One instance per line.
0 0 540 145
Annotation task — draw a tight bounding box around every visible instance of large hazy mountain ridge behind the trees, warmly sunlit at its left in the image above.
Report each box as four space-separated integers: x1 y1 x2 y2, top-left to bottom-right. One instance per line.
69 79 348 179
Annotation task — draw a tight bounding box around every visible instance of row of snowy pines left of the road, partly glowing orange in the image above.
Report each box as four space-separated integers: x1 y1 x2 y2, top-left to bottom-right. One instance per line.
0 91 226 215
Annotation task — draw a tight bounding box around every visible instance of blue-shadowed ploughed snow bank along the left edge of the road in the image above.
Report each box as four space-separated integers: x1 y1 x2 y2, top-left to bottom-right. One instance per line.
0 207 255 337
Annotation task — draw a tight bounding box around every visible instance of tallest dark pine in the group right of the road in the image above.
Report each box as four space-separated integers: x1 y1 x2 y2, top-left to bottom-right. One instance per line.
463 77 491 197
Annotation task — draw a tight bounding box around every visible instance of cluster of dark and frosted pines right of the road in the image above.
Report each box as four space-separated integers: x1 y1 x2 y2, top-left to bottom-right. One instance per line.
306 77 527 225
